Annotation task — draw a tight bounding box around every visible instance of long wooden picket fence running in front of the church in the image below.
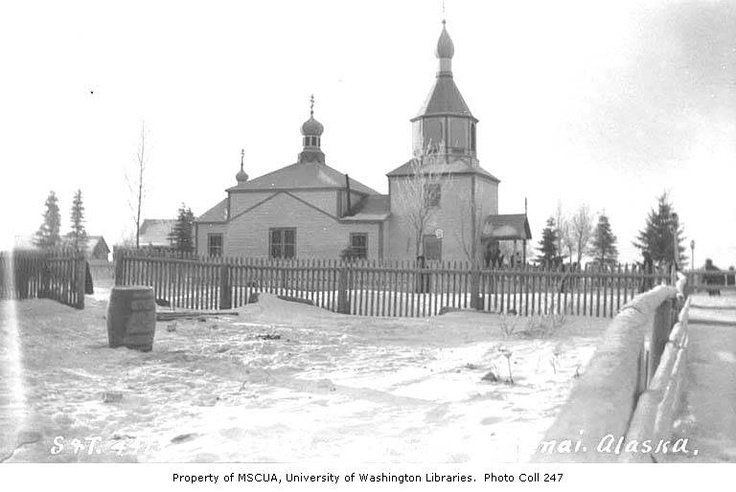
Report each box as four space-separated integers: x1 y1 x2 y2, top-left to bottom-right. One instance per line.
115 250 667 317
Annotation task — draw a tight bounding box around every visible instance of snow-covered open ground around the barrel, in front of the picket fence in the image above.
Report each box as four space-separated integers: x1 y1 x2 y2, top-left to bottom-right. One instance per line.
0 288 610 463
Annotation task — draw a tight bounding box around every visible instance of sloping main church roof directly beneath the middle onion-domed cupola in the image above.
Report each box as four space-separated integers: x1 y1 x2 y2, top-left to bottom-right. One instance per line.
227 162 378 195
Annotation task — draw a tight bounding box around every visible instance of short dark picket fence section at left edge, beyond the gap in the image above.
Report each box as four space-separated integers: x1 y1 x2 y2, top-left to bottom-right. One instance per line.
0 250 86 309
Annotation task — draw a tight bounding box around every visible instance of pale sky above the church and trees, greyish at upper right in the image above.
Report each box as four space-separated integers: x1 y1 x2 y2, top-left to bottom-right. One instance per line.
0 0 736 267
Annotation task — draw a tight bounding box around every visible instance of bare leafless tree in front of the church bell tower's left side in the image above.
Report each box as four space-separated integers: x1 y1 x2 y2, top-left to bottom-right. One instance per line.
394 147 452 256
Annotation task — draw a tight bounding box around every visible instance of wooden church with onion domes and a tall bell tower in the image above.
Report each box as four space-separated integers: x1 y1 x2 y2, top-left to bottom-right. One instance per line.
195 21 531 261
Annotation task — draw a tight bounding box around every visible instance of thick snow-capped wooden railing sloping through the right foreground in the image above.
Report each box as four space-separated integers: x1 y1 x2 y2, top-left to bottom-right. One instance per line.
534 285 687 462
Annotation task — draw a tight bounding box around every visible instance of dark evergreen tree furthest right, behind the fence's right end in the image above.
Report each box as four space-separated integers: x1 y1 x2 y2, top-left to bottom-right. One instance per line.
634 192 685 265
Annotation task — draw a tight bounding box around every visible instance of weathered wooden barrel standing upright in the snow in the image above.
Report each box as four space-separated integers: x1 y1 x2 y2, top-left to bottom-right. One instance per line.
107 285 156 352
